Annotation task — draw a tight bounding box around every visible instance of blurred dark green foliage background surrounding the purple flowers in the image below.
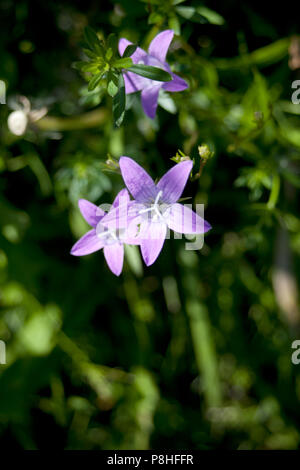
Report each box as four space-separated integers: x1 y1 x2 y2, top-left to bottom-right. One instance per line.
0 0 300 449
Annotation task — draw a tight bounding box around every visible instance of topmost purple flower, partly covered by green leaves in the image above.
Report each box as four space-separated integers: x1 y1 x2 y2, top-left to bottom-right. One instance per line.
119 29 188 119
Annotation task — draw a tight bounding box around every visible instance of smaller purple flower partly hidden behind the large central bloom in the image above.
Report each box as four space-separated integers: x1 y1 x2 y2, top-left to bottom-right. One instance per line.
71 189 139 276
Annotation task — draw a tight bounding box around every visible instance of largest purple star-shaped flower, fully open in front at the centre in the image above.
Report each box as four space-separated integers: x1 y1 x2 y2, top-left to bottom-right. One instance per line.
104 157 211 266
